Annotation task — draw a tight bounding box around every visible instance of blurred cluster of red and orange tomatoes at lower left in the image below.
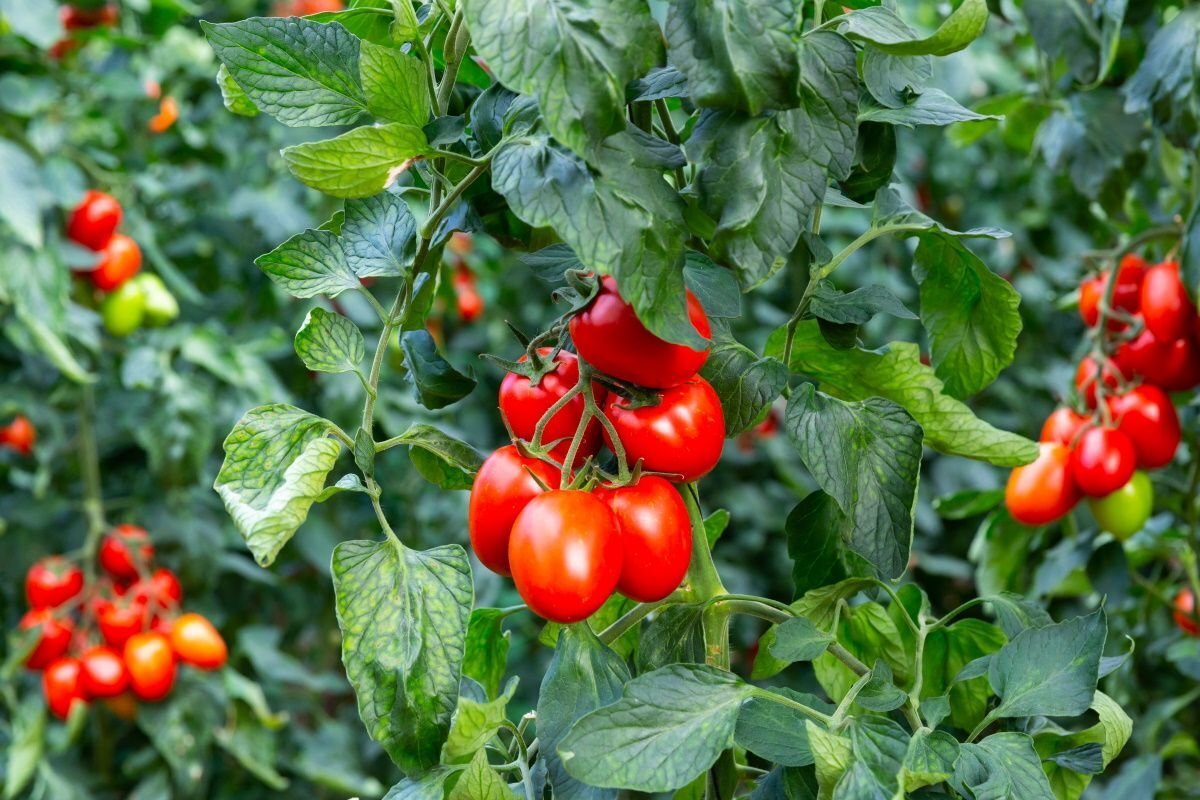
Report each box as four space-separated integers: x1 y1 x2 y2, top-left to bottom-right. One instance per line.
20 524 228 720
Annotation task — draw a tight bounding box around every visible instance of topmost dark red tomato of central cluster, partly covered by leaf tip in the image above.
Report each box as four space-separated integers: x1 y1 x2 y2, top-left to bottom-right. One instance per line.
570 276 713 389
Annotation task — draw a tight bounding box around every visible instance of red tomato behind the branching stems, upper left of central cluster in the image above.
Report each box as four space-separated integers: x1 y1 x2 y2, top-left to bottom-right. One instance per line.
499 348 607 465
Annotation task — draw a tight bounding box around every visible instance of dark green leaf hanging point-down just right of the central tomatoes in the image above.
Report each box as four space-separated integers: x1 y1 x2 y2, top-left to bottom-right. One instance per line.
784 384 922 579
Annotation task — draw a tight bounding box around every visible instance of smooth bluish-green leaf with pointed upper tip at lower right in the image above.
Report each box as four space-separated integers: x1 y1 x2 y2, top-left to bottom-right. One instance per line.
988 609 1108 718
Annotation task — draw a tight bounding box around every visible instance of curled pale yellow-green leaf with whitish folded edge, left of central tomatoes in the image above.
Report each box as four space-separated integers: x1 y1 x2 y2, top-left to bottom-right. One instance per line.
212 403 342 566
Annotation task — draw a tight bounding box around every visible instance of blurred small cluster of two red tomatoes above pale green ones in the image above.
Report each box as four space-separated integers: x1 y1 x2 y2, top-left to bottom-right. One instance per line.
67 190 179 336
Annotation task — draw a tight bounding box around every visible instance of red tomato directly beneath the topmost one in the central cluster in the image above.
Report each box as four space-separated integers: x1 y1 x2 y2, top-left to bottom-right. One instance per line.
604 378 725 483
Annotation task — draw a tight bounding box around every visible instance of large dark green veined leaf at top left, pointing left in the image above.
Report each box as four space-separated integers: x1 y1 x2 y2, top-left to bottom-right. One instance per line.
200 17 366 127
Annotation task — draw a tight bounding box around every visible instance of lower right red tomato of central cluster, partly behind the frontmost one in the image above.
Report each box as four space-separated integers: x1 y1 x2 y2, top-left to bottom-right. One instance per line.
594 475 691 603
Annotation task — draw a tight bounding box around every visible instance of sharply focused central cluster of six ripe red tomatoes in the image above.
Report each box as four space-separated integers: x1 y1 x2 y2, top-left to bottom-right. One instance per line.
468 277 725 622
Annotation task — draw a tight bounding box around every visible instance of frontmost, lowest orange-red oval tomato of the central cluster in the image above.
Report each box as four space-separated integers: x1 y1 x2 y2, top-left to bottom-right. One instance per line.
509 489 622 624
